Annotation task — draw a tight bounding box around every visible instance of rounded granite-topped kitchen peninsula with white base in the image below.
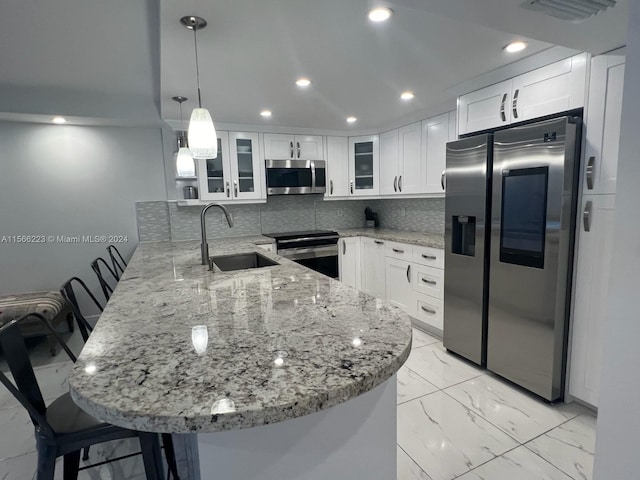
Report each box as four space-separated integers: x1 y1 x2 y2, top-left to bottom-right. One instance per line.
69 237 411 480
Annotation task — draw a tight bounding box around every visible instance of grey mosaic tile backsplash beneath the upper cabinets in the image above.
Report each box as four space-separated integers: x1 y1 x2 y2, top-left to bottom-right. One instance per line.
136 195 444 242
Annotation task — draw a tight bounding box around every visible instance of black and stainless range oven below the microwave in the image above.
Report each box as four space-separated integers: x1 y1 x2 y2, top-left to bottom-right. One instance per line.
264 230 340 278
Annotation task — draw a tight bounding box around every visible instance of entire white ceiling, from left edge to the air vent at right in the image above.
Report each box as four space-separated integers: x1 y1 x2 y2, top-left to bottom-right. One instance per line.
0 0 628 130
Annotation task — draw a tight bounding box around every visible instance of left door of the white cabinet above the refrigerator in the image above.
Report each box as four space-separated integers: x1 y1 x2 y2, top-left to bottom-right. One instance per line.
458 80 511 135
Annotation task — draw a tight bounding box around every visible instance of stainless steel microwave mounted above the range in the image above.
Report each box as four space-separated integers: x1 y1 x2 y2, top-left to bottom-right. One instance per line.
265 160 327 195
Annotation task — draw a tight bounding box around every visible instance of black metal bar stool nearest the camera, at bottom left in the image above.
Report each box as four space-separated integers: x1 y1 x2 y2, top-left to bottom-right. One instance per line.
0 313 164 480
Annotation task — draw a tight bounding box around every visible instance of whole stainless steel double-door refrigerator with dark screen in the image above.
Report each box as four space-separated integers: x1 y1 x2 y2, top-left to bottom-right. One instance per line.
444 116 581 401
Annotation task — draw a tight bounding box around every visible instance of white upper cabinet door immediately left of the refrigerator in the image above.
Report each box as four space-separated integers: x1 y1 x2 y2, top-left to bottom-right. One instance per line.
421 113 455 193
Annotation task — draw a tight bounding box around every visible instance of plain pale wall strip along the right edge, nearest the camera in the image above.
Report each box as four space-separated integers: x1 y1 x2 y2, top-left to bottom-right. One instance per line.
594 0 640 480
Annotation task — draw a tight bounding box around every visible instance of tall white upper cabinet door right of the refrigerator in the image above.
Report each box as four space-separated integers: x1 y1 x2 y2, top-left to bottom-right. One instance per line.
582 55 625 194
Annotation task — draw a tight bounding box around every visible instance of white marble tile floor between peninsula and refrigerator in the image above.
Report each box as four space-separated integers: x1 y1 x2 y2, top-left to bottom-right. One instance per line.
397 330 596 480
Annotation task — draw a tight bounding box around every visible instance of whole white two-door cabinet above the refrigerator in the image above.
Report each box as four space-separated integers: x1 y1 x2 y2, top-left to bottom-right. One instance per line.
458 53 588 135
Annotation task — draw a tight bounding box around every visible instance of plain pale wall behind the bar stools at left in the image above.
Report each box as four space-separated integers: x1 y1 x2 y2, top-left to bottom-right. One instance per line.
0 122 167 312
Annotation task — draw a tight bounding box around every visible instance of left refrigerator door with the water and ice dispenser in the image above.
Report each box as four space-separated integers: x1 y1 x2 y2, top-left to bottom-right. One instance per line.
444 135 491 365
